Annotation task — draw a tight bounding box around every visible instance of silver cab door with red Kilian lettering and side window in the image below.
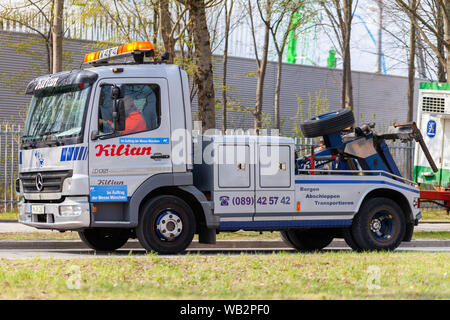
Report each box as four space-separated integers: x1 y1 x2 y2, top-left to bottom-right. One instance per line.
89 78 172 202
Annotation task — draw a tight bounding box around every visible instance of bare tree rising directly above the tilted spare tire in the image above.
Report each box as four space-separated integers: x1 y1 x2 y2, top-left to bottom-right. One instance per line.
320 0 358 108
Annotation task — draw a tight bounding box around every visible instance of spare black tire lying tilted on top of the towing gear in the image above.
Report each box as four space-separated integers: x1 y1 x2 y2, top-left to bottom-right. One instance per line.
300 109 355 138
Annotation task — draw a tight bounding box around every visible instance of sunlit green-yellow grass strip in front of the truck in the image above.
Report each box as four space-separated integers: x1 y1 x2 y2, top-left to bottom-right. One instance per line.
0 252 450 300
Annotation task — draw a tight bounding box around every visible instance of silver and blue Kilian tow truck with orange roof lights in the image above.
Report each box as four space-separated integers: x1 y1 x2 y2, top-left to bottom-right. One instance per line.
16 41 432 254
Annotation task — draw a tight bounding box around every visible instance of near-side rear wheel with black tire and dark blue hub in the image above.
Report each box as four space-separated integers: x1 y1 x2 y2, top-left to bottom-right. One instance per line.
351 198 406 251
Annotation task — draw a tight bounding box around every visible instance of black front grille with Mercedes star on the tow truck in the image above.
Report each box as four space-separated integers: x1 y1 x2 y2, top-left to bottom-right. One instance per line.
19 170 72 193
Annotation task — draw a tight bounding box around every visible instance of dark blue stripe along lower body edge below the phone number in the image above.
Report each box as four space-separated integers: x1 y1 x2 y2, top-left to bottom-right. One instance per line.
219 219 352 230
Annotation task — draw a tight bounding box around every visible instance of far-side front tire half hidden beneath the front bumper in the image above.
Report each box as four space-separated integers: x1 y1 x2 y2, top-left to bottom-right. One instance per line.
78 228 130 251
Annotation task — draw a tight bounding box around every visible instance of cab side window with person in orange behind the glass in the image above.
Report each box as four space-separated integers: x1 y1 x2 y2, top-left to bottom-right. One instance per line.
98 84 161 136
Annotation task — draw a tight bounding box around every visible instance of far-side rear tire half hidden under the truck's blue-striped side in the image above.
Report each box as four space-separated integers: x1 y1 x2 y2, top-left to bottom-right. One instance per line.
285 229 334 252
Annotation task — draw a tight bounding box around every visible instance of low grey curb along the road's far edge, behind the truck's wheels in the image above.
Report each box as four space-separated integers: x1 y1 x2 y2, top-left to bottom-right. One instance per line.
0 239 450 250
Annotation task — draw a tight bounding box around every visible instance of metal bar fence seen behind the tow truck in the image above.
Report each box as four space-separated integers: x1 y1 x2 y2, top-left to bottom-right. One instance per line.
0 127 439 213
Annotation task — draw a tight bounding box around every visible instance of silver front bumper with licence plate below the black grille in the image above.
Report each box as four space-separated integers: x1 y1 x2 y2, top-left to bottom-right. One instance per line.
19 197 91 231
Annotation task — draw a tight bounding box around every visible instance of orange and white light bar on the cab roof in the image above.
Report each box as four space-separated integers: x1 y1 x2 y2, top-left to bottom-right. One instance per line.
83 41 154 64
